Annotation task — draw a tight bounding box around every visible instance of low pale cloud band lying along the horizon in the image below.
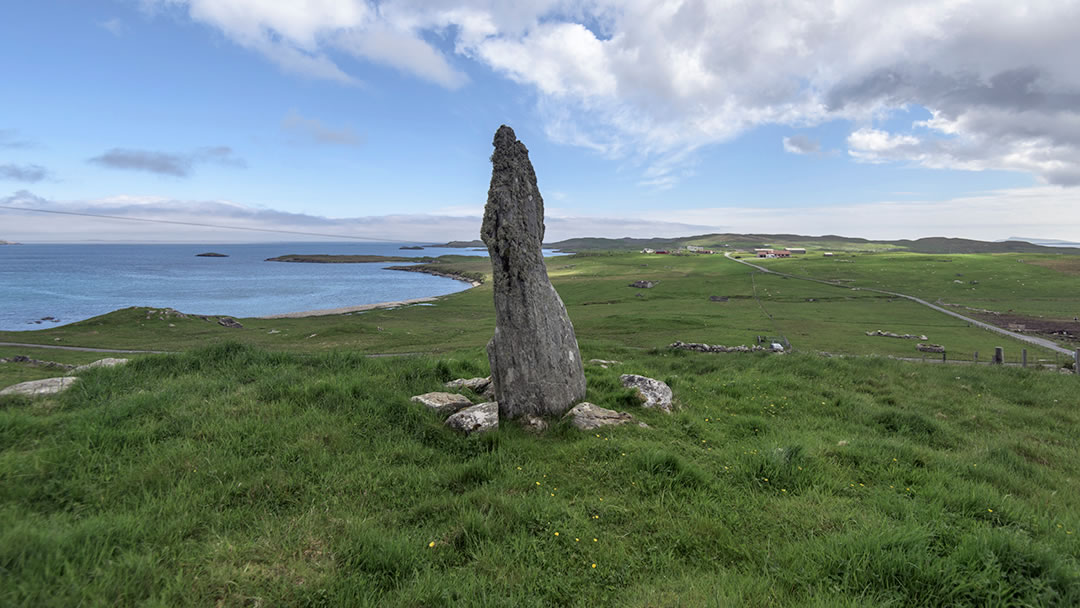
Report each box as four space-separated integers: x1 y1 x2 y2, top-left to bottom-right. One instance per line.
0 186 1080 243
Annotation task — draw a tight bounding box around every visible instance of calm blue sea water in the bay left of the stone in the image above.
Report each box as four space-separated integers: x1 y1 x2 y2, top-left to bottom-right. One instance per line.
0 242 498 330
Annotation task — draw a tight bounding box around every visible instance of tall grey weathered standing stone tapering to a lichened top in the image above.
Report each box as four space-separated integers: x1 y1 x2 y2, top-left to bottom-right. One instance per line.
481 125 585 418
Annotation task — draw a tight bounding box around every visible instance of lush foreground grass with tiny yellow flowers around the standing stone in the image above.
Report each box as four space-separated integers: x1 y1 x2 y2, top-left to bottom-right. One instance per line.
0 345 1080 607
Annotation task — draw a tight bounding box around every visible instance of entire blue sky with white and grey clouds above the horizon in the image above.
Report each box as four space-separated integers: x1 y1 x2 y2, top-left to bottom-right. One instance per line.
0 0 1080 243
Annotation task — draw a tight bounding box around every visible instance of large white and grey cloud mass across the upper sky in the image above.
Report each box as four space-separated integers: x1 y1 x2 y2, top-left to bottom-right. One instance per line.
144 0 1080 187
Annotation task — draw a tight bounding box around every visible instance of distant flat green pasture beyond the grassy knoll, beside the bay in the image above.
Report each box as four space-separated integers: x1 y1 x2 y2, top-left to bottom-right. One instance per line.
0 254 1062 362
